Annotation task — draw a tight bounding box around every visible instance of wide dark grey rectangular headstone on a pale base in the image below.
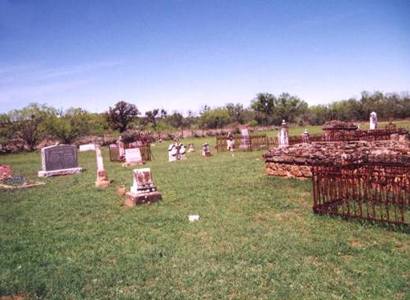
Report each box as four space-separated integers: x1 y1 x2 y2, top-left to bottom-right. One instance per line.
38 145 82 177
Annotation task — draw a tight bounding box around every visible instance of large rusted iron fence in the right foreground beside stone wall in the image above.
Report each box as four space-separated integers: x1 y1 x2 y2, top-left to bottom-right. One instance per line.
312 158 410 227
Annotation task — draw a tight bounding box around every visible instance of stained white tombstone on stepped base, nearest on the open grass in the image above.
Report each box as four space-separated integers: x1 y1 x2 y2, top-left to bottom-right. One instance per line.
124 168 161 207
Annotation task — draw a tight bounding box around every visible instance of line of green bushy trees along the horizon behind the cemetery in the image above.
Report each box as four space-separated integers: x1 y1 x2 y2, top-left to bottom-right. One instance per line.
0 92 410 150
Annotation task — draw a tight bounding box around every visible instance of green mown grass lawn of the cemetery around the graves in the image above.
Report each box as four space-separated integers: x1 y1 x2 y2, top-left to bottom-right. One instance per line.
0 138 410 299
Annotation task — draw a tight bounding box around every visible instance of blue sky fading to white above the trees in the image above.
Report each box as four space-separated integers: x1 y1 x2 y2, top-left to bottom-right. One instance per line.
0 0 410 112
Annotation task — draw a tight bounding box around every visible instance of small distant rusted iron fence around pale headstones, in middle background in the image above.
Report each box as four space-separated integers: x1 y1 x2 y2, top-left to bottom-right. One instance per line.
215 134 277 152
